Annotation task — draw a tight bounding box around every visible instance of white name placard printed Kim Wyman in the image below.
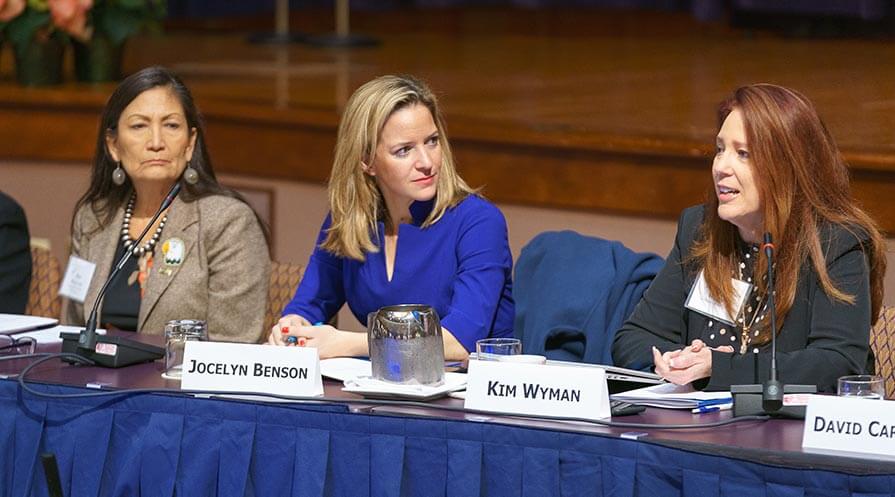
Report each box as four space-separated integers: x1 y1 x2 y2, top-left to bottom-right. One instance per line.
464 360 611 419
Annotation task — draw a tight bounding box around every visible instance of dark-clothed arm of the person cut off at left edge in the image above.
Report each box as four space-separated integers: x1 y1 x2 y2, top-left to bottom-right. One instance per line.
0 193 31 314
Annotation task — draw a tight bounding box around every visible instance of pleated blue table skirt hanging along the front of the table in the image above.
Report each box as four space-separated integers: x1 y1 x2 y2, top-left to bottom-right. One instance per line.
0 381 895 497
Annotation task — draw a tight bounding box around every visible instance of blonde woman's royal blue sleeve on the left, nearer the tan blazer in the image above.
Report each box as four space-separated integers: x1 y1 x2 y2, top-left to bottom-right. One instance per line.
283 216 345 323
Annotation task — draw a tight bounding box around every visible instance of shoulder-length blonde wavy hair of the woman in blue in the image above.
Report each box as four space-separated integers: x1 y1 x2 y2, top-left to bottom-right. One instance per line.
320 75 475 261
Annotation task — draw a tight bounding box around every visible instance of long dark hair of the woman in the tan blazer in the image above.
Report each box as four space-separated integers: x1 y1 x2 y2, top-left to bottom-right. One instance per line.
72 66 270 244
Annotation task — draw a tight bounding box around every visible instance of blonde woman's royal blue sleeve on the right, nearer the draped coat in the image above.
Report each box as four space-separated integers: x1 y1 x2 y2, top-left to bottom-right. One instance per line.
441 202 513 351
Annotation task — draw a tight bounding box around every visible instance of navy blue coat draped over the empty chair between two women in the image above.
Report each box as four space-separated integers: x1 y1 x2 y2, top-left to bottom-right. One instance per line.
513 231 664 364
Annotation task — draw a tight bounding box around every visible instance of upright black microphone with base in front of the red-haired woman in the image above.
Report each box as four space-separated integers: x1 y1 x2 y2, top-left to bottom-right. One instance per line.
730 233 817 419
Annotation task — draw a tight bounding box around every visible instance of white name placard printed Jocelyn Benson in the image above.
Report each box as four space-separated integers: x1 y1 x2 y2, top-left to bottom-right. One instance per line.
180 342 323 397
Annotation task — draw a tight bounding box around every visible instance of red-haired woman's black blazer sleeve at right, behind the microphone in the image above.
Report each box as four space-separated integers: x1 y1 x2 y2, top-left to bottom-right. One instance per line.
706 227 871 392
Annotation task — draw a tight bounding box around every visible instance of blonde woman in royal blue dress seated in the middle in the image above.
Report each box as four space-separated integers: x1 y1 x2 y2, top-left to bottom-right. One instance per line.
269 76 513 360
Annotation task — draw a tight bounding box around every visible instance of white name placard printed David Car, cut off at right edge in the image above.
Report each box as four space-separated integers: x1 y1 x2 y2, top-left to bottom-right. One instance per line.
802 395 895 457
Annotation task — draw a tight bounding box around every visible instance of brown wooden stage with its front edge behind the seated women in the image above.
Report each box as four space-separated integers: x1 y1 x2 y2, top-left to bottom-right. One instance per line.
0 10 895 232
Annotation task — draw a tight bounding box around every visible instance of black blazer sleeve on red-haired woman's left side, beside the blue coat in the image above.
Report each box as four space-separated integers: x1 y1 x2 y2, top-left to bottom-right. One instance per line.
612 206 703 370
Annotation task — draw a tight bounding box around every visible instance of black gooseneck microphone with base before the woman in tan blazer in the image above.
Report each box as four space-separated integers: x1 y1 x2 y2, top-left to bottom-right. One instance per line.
60 181 180 368
